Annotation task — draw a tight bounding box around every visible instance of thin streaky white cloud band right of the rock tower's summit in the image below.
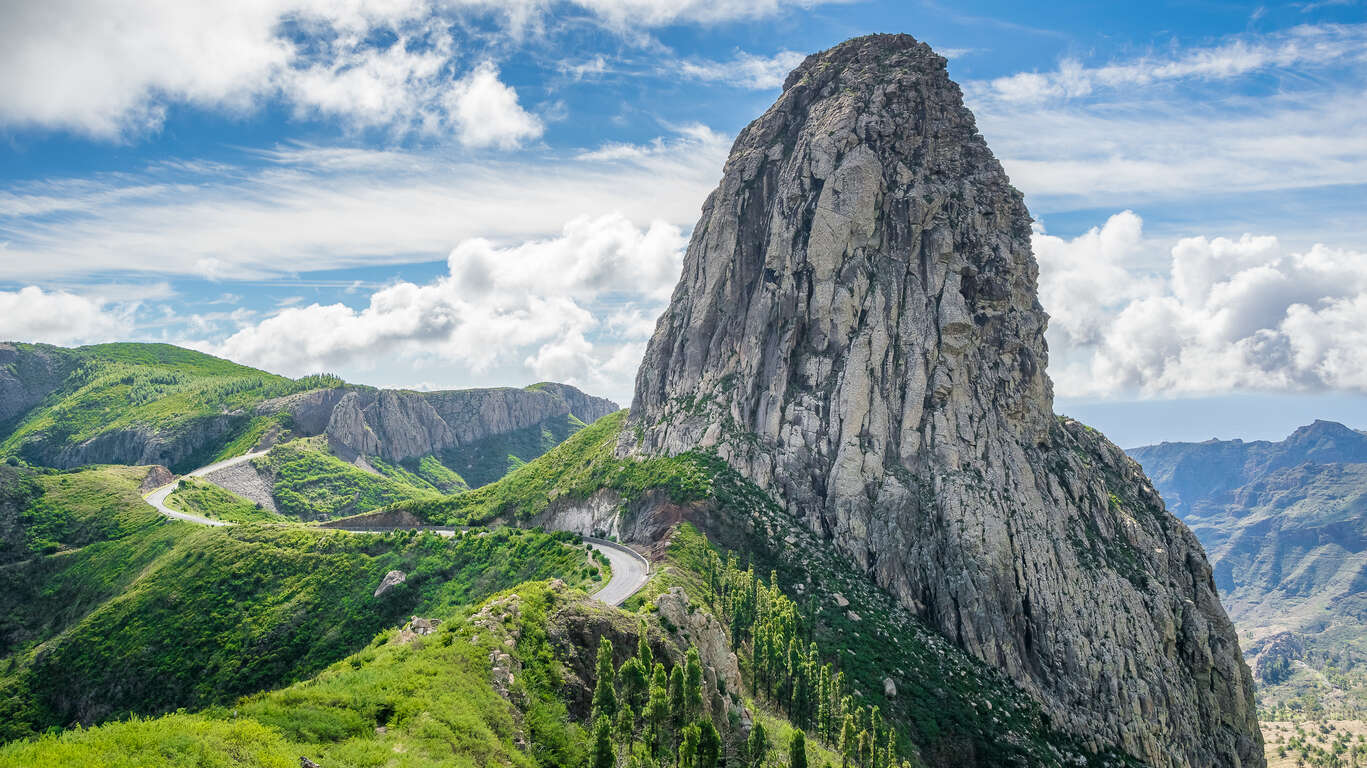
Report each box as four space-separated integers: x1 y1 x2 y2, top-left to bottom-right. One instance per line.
964 25 1367 210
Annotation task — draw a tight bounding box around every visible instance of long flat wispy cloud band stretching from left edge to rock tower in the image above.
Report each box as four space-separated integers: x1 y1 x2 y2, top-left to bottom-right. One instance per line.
0 126 729 282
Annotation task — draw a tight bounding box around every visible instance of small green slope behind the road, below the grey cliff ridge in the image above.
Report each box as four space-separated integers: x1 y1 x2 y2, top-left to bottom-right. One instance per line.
252 437 437 521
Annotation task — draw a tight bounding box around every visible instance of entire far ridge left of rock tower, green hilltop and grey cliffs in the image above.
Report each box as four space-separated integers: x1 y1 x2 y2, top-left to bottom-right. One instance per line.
0 337 617 486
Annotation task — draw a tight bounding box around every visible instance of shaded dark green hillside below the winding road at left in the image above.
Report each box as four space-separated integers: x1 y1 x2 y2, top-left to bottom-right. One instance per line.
0 456 592 738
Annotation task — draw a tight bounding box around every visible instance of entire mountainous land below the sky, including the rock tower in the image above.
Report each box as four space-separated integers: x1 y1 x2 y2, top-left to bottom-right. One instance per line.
0 34 1317 768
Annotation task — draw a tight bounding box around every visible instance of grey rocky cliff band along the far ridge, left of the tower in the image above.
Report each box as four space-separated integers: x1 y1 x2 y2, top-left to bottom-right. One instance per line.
258 384 618 461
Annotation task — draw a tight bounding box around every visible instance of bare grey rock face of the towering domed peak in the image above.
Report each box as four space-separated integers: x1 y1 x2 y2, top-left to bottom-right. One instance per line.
619 36 1263 765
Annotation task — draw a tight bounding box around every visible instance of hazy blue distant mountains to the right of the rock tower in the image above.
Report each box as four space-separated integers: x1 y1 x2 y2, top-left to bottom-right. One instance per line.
1128 421 1367 713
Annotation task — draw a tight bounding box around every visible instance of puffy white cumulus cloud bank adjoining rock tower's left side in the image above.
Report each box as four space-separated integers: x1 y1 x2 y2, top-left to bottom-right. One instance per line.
211 213 686 398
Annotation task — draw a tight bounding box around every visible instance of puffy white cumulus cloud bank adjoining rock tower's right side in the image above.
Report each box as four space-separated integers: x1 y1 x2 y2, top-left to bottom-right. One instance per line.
1033 210 1367 396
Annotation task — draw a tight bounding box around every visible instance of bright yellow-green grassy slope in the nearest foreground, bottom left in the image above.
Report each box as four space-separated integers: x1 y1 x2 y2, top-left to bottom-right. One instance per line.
0 584 838 768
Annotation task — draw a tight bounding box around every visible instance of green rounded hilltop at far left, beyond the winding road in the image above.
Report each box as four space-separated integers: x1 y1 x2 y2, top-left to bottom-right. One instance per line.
0 343 340 470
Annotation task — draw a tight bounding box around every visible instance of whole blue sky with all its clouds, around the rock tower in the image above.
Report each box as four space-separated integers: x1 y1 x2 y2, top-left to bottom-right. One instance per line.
0 0 1367 445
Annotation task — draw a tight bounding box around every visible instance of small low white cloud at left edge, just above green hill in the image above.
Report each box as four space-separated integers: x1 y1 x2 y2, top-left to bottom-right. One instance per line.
0 286 137 344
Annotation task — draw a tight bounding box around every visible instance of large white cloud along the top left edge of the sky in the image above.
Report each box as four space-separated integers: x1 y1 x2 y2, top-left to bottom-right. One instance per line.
0 0 842 138
